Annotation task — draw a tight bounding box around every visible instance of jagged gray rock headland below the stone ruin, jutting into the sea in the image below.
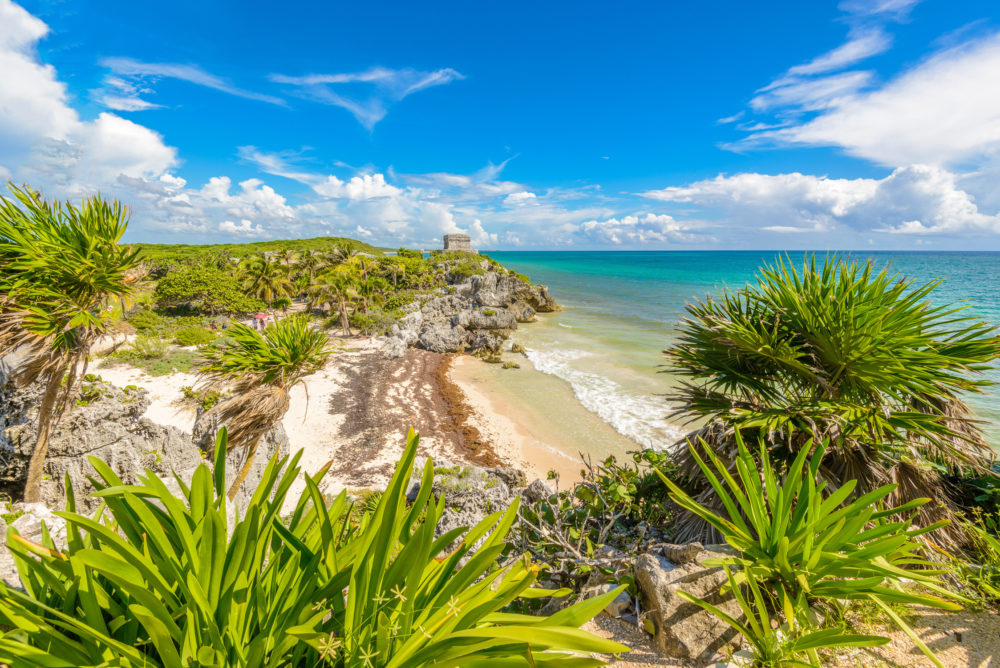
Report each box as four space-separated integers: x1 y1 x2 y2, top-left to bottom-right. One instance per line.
384 260 559 357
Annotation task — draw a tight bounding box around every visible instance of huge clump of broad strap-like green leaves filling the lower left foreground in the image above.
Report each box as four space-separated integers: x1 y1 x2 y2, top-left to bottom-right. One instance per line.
0 430 627 668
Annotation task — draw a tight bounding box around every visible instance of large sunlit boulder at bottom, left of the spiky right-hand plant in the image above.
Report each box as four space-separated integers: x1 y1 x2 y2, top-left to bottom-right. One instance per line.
635 546 741 661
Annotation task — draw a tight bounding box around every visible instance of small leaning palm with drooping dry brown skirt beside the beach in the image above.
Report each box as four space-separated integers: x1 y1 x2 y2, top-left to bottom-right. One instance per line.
198 314 333 501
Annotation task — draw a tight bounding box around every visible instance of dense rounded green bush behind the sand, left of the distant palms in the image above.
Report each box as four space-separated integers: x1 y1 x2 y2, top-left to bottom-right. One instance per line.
153 264 264 315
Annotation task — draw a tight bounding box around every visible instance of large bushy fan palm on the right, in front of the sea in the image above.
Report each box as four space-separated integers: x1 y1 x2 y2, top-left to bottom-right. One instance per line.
666 256 1000 538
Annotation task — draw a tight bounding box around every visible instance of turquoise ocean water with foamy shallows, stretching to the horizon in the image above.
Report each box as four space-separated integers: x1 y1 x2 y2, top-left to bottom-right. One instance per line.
489 251 1000 449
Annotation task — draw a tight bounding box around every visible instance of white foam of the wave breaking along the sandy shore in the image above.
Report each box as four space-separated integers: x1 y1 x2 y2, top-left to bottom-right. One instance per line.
527 348 684 450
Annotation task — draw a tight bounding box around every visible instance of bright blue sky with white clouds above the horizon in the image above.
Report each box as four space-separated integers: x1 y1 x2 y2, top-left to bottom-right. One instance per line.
0 0 1000 249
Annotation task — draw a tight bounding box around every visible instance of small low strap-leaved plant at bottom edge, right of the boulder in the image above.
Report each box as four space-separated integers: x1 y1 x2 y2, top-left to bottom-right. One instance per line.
677 566 889 668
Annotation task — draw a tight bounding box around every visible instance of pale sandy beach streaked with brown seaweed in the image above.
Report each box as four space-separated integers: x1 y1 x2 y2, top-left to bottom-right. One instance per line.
95 338 580 497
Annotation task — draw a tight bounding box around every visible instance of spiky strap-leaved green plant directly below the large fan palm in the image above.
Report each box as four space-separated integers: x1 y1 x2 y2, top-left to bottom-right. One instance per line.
658 432 960 665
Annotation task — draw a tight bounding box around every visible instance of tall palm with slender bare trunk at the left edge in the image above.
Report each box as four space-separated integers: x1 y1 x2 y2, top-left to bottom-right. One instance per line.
0 185 139 503
